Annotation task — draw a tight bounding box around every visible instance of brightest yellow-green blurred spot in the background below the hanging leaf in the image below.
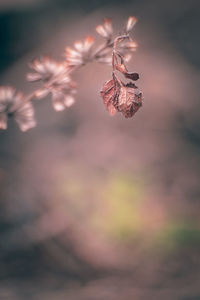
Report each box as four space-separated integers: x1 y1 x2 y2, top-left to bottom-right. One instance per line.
95 174 143 240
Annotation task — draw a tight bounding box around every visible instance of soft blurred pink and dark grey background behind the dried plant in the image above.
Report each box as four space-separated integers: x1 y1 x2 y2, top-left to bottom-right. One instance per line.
0 0 200 300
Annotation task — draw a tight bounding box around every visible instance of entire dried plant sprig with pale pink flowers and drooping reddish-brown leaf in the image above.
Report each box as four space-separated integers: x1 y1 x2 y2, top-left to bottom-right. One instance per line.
0 17 142 131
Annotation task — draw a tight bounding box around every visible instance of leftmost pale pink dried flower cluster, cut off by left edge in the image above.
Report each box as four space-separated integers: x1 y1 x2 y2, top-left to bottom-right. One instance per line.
0 86 36 131
